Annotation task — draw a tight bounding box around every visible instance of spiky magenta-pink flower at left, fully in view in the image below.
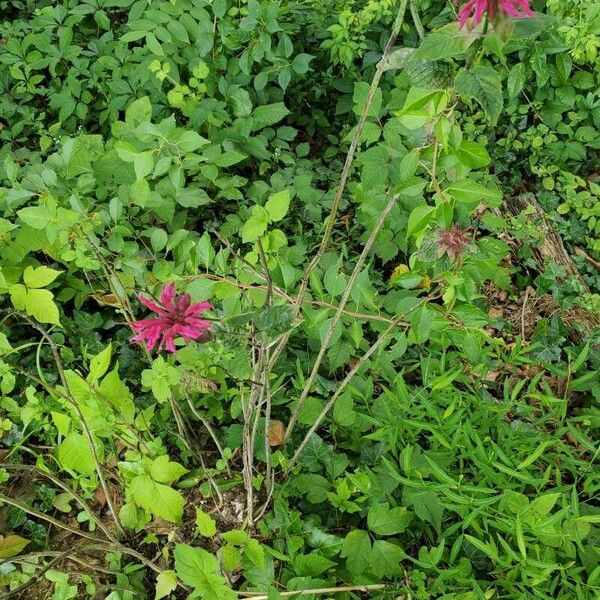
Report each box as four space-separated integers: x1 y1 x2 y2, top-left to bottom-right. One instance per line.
130 283 212 352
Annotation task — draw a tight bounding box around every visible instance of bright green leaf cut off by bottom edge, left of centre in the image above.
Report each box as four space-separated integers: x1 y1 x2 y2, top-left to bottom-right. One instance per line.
173 544 237 600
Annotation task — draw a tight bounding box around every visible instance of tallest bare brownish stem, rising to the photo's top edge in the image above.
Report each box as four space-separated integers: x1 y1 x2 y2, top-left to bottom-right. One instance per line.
264 0 408 365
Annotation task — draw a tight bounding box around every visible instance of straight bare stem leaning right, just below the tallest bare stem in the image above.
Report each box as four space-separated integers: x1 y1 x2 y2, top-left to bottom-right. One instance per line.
283 195 399 444
